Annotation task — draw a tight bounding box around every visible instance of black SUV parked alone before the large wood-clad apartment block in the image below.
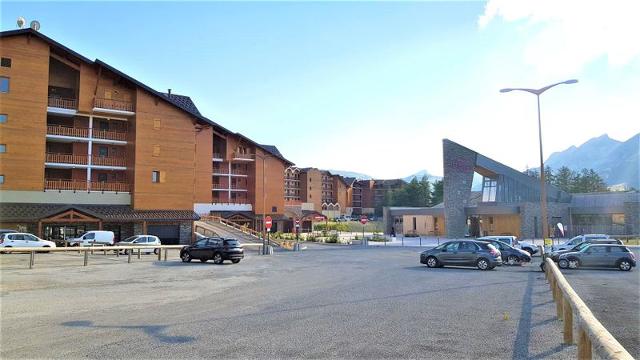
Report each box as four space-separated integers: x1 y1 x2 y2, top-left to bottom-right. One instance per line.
180 238 244 264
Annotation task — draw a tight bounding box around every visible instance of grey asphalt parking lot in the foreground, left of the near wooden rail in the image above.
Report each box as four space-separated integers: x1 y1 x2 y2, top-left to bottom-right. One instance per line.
0 245 637 359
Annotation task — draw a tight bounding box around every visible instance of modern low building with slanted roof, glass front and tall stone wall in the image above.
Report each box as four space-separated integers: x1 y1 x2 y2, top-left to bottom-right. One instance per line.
384 139 640 239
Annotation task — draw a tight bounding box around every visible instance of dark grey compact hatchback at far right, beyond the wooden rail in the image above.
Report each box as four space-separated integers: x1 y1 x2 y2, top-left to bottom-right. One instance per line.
558 244 636 271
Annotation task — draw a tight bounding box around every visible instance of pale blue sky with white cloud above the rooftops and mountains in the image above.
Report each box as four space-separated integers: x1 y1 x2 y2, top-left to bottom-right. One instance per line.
0 0 640 178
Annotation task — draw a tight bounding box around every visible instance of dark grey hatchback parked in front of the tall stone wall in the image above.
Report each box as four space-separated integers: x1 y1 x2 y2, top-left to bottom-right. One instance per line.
420 240 502 270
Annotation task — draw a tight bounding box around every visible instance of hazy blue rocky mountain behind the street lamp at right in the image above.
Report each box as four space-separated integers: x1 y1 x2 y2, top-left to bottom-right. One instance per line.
545 133 640 189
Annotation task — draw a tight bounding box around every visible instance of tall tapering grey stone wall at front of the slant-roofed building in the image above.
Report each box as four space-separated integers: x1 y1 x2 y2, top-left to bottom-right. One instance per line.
442 139 477 238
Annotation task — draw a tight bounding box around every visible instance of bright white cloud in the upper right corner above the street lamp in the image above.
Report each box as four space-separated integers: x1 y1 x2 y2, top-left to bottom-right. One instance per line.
478 0 640 76
